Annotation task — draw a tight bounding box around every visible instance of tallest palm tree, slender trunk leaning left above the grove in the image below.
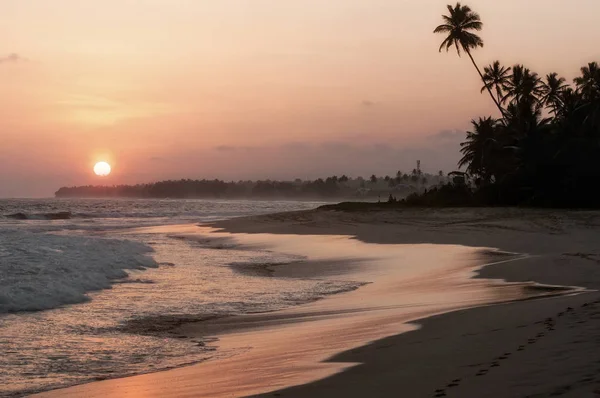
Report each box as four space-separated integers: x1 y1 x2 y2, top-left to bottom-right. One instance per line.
433 3 504 114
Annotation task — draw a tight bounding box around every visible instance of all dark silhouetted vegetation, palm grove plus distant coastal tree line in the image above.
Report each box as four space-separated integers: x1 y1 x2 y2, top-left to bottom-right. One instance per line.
56 3 600 209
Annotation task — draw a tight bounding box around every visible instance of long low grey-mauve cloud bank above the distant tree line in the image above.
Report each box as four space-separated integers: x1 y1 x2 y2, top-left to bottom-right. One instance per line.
164 134 460 180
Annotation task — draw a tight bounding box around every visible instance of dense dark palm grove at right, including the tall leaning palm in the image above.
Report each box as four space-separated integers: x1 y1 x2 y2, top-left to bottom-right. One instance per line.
429 3 600 207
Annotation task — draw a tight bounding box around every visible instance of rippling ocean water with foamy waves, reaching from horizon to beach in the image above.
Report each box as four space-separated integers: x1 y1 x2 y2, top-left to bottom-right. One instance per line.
0 199 356 397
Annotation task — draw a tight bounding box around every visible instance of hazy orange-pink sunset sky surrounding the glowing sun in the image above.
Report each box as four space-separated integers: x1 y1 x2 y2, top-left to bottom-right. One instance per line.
0 0 600 197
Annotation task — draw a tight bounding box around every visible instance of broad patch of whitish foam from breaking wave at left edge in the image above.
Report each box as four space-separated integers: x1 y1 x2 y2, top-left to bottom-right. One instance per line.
0 229 157 313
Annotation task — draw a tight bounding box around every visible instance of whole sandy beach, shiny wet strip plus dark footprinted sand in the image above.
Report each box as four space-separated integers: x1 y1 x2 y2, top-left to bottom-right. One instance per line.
34 209 600 397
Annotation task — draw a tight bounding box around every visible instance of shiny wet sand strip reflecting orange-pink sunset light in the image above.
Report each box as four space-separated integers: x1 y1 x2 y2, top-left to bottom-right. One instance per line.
32 225 576 397
